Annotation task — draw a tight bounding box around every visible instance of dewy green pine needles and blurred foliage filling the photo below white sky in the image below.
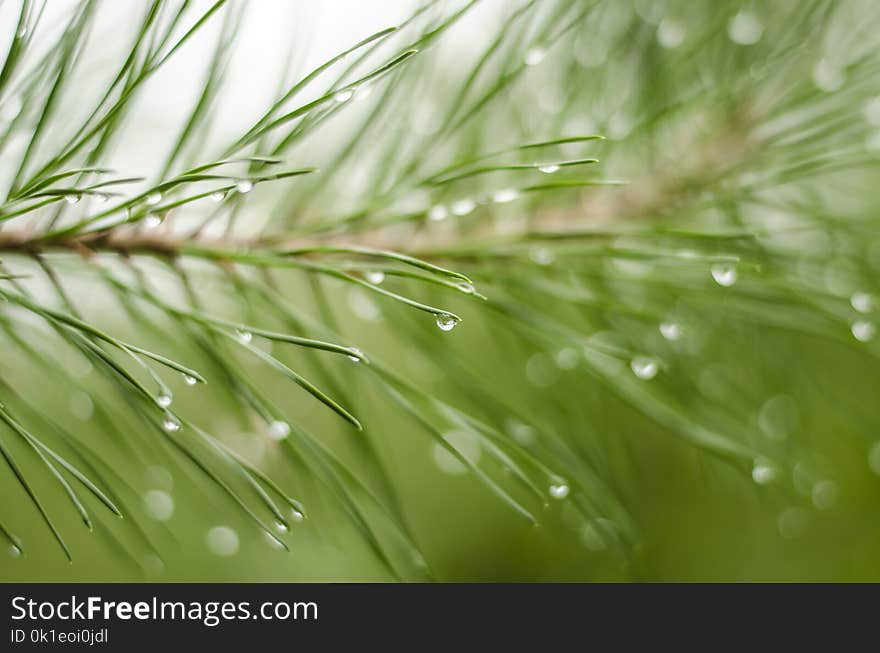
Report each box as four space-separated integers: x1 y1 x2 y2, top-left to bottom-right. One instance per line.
0 0 880 580
